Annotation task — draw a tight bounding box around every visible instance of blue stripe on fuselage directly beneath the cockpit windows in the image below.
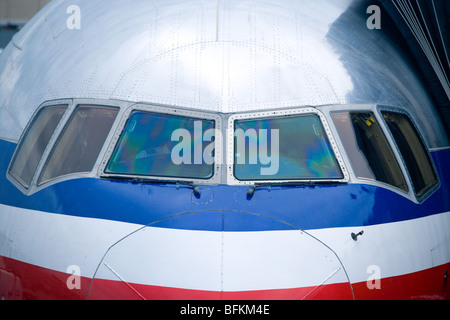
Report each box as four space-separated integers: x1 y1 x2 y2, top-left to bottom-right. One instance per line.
0 140 450 232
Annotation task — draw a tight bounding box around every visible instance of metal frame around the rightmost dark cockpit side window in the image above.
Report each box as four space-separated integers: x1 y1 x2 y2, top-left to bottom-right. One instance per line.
376 105 441 203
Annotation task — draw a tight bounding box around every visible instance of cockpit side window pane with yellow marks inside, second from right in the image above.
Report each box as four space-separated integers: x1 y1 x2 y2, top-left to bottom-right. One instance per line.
331 111 408 192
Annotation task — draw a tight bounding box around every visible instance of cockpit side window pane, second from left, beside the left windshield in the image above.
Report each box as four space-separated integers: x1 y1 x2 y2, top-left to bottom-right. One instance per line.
38 105 119 185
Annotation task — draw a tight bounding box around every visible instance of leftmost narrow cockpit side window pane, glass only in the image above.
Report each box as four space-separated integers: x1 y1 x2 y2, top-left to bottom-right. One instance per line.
9 104 68 189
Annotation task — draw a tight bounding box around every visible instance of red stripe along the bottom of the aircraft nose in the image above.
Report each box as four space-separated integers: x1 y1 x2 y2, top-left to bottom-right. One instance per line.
0 256 450 300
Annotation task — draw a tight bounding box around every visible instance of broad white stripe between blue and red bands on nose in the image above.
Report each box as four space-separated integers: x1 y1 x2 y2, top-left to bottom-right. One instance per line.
0 205 450 292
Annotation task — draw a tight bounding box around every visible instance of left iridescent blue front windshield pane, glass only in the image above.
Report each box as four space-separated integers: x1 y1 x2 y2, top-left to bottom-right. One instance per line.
105 111 214 179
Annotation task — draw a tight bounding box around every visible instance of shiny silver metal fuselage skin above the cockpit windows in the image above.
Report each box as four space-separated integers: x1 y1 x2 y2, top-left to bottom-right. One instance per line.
0 0 448 147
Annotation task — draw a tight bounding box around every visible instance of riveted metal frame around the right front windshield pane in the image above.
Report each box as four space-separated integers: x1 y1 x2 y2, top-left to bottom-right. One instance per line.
225 107 349 185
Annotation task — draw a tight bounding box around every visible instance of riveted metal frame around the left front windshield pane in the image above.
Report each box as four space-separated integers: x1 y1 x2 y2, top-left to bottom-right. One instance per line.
98 103 223 185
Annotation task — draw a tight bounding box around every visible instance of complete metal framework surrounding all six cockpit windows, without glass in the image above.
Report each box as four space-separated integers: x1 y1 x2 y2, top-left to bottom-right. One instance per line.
6 98 441 203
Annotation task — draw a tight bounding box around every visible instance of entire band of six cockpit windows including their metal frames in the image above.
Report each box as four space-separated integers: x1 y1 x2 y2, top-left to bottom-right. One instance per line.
12 99 439 201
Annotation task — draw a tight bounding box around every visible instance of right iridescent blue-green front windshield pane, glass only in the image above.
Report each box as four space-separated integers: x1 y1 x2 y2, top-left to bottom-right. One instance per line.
234 114 343 180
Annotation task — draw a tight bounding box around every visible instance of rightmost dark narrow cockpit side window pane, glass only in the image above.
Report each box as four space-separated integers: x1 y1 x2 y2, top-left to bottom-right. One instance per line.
381 111 437 198
